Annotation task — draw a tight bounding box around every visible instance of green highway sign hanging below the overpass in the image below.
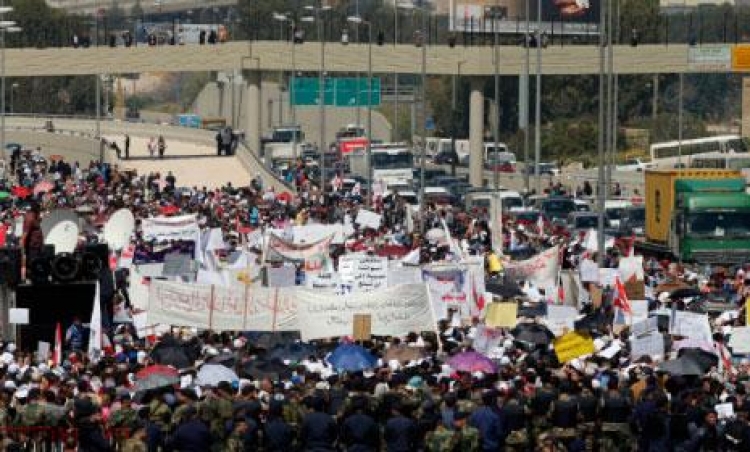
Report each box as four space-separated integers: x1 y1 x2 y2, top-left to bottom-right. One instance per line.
290 77 381 107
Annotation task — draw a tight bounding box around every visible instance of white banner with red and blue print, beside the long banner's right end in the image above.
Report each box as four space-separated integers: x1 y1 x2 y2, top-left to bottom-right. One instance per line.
422 266 472 319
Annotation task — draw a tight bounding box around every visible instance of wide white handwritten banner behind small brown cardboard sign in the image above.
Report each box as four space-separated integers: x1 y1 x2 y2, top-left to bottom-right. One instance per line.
297 284 435 341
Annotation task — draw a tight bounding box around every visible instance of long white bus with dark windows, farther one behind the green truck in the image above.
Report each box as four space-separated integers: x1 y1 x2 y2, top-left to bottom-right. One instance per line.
650 135 747 167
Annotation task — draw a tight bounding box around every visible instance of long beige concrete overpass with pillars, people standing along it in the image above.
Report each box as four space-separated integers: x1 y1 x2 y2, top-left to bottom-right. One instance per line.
5 41 750 185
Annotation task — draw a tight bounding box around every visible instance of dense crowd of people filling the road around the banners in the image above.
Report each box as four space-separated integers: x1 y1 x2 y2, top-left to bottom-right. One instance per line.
0 141 750 452
